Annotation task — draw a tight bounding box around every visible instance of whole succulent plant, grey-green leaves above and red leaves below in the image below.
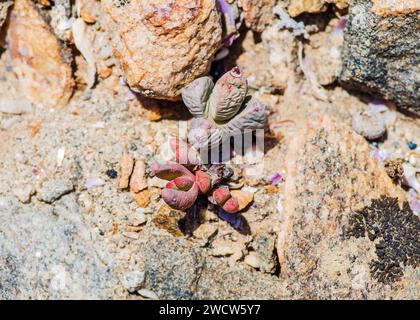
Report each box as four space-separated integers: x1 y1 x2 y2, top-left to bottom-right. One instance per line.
152 67 267 214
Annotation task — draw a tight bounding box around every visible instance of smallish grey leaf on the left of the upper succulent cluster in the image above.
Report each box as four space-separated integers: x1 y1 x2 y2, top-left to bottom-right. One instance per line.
182 77 214 117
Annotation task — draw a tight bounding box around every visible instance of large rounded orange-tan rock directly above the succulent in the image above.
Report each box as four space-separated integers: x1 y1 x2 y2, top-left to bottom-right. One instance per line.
104 0 222 100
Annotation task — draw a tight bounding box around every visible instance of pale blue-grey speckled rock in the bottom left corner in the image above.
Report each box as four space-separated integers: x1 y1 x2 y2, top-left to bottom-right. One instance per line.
0 197 117 299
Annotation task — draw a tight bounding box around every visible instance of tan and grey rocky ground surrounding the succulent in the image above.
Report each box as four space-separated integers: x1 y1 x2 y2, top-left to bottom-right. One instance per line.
0 0 420 299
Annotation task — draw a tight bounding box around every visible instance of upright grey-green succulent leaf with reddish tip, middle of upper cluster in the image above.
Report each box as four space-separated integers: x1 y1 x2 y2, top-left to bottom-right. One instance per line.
209 67 248 122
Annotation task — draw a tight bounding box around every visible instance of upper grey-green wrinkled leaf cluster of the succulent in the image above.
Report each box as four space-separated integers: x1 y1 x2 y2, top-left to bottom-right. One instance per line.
182 67 267 149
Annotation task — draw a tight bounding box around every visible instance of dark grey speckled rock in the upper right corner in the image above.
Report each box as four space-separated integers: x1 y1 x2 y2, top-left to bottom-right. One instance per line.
340 0 420 114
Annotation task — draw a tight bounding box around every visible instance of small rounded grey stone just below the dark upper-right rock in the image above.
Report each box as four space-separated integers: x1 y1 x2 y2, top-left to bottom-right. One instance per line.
352 113 386 140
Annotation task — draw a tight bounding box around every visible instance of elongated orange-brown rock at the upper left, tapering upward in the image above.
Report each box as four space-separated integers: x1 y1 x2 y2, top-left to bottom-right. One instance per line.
7 0 74 107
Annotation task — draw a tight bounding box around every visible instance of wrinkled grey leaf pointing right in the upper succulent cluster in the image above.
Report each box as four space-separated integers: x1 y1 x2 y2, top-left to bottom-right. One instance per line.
223 98 267 136
